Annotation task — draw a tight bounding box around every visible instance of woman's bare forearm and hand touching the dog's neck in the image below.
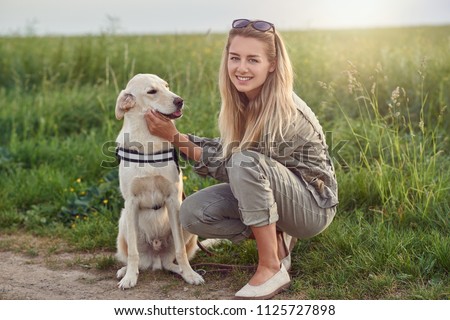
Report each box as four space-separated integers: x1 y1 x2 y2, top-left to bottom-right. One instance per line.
145 110 203 162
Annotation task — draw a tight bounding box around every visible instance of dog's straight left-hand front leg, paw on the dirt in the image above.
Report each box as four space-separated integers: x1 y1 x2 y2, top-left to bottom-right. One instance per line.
118 197 139 289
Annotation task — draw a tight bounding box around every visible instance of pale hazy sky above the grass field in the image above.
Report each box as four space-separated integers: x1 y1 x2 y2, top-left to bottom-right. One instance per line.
0 0 450 35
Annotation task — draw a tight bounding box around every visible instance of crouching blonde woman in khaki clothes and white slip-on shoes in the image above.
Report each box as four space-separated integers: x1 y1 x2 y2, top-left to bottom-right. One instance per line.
146 19 338 299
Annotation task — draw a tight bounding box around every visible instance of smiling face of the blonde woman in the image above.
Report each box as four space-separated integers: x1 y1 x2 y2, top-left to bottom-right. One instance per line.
228 36 275 101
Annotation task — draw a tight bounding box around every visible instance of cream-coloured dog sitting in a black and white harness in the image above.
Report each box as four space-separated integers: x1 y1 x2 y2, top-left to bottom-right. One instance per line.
116 74 207 289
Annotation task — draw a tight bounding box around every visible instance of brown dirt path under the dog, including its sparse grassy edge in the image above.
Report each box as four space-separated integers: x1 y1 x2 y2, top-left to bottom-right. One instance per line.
0 235 294 300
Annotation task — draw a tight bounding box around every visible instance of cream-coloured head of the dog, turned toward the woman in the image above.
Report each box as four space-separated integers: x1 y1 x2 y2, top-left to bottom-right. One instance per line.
116 74 183 120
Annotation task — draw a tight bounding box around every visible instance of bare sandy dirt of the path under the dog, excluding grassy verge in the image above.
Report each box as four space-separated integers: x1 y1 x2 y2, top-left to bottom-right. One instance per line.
0 252 233 300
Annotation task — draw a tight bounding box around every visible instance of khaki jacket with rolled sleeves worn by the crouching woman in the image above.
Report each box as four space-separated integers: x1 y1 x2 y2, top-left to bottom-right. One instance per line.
188 94 338 208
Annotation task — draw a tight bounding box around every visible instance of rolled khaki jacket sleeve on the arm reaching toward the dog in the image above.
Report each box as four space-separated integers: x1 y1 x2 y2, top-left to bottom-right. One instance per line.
188 134 228 182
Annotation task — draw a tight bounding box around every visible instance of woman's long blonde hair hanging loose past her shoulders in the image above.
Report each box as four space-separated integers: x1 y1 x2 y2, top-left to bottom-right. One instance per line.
219 25 296 158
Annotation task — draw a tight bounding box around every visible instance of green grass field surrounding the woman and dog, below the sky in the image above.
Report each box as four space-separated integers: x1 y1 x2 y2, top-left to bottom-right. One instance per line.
0 26 450 299
